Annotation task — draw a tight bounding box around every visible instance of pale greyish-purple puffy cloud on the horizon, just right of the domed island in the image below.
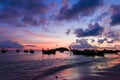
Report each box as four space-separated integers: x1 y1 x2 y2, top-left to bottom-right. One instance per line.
70 39 96 49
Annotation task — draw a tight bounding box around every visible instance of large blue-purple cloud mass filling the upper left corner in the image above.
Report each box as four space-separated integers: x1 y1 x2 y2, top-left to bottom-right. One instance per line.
0 0 49 27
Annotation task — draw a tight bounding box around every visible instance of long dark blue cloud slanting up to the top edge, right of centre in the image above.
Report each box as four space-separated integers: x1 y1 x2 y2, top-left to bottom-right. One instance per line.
57 0 103 20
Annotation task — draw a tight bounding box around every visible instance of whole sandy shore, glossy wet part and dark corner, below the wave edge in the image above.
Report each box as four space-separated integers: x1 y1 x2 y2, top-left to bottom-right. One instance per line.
42 54 120 80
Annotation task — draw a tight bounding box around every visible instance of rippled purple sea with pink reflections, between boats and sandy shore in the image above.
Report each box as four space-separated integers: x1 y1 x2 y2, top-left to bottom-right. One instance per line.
0 51 118 80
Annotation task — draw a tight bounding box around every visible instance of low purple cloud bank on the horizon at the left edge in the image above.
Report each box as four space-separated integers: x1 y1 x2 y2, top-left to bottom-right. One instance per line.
0 40 23 48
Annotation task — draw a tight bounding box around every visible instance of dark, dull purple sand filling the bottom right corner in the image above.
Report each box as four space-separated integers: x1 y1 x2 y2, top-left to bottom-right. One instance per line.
81 65 120 80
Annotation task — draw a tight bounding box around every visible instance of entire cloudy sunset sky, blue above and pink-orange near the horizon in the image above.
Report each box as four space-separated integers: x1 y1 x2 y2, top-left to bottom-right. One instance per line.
0 0 120 49
